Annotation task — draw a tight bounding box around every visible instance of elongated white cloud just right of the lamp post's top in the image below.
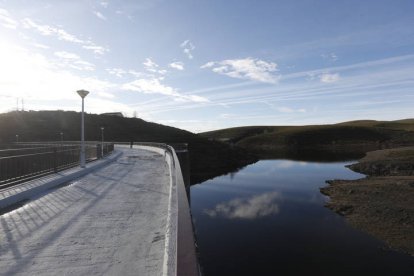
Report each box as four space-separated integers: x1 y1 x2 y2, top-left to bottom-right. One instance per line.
121 78 209 103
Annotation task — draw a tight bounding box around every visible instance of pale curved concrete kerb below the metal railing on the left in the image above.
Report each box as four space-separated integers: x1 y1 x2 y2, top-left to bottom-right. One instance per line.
0 150 123 210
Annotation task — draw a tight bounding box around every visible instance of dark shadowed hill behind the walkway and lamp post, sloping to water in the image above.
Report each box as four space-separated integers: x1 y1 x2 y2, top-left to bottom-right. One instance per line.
0 111 256 184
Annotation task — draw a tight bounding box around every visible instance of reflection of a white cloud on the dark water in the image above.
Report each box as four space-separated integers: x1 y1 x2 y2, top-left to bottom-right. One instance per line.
204 192 280 219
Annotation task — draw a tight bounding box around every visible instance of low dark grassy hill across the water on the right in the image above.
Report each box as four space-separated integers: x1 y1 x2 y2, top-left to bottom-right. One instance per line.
200 119 414 158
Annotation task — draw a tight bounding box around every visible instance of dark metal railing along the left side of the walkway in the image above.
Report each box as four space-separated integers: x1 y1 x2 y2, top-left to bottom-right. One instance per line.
0 142 114 189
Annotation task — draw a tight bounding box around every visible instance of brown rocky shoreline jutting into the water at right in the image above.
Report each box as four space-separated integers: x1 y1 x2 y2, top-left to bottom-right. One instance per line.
321 147 414 256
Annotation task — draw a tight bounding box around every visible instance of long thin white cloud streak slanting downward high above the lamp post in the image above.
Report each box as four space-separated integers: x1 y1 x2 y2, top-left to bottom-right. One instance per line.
21 18 109 55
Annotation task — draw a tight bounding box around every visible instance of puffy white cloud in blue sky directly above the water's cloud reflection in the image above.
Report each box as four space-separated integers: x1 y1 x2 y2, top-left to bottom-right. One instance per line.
201 58 279 83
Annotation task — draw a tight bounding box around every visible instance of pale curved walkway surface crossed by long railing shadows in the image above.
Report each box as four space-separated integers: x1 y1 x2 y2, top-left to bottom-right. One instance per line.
0 149 170 275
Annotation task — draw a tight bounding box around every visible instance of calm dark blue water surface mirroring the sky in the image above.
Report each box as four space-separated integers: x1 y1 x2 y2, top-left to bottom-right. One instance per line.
191 160 414 276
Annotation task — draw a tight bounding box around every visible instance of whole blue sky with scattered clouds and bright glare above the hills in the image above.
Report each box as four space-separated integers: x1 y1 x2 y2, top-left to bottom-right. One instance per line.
0 0 414 132
